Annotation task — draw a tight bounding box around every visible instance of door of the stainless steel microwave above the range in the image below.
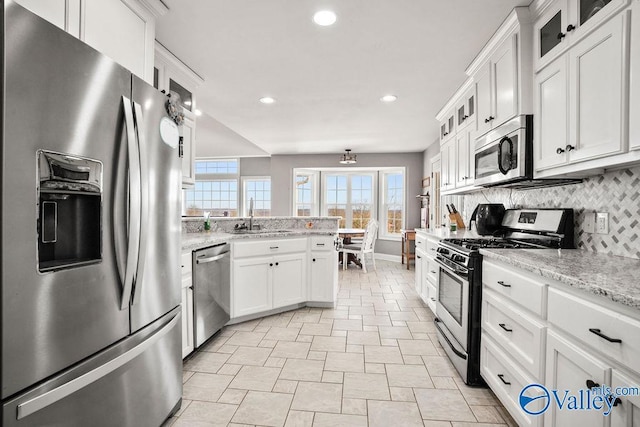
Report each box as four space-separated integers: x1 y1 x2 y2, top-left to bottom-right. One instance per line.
474 129 530 185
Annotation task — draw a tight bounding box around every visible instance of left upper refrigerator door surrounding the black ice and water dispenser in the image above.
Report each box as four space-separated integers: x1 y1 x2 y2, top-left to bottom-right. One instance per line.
0 1 131 399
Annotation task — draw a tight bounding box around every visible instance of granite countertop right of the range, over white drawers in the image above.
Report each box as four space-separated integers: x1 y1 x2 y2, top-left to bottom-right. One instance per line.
480 249 640 310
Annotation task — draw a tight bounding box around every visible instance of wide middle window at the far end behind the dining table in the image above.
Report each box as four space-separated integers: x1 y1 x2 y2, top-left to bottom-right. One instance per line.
323 173 376 228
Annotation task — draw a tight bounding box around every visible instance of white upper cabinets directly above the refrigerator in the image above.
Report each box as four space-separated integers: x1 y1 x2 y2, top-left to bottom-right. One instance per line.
17 0 169 83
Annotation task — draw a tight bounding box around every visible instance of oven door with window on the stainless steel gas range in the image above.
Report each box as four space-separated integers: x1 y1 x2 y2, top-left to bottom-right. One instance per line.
436 261 469 352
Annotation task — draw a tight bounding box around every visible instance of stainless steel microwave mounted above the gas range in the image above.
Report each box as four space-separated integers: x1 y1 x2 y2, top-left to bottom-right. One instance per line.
474 114 581 188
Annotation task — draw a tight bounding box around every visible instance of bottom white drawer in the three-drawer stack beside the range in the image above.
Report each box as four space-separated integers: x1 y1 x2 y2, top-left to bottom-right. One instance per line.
480 336 543 427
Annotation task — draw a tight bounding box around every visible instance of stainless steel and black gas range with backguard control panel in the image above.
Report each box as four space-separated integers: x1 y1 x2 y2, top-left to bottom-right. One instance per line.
435 209 575 385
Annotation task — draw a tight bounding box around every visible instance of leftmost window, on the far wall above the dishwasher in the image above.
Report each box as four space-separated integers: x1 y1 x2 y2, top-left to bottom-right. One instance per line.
184 159 238 216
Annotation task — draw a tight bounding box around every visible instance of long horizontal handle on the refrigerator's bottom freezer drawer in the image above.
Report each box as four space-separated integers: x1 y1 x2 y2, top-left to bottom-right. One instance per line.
17 314 180 420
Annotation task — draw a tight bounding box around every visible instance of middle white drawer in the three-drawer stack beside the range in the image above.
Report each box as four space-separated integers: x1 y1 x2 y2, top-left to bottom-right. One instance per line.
482 289 546 381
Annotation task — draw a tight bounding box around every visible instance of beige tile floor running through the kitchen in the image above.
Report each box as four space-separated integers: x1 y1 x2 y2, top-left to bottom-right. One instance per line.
165 261 516 427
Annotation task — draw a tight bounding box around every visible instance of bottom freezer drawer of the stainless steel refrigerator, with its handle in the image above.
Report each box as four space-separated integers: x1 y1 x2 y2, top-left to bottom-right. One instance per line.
2 308 182 427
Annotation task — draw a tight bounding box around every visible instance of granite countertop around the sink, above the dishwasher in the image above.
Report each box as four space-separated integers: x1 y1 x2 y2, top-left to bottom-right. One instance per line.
182 230 338 252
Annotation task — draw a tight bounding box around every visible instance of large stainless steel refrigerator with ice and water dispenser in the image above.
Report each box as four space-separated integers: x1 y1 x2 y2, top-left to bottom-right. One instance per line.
0 1 182 427
